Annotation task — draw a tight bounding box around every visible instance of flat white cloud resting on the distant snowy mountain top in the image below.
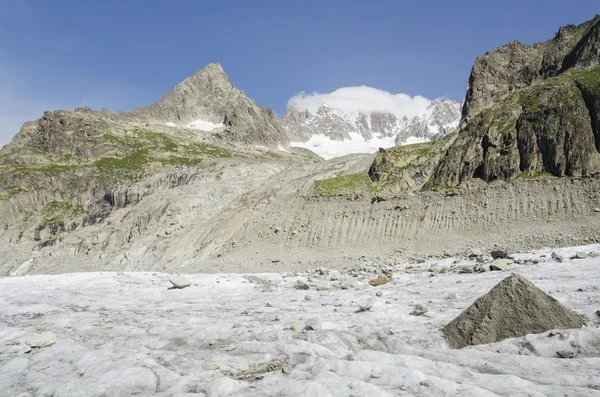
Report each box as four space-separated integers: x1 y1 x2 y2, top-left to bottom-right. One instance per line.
288 85 431 118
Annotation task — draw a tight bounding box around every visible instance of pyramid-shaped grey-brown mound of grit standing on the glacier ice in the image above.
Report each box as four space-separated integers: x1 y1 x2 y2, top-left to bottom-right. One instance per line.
442 274 584 349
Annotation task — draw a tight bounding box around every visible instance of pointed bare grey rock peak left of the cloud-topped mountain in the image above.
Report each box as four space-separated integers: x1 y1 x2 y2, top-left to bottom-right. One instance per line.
119 63 289 147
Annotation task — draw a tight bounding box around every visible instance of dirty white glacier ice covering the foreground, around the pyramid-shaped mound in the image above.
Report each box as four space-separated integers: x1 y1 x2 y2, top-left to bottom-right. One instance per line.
0 245 600 397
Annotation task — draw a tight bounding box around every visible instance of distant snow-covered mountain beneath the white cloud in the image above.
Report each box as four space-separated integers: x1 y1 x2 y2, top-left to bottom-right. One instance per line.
283 98 460 159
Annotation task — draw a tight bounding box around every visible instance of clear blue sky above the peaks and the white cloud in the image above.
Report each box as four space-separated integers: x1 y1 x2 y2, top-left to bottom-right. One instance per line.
0 0 600 144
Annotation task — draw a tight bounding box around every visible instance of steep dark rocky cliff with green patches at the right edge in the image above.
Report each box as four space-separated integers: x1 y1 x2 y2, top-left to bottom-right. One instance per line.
435 16 600 186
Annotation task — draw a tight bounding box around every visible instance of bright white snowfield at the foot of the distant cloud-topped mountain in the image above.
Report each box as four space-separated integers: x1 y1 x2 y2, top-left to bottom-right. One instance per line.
290 132 396 160
